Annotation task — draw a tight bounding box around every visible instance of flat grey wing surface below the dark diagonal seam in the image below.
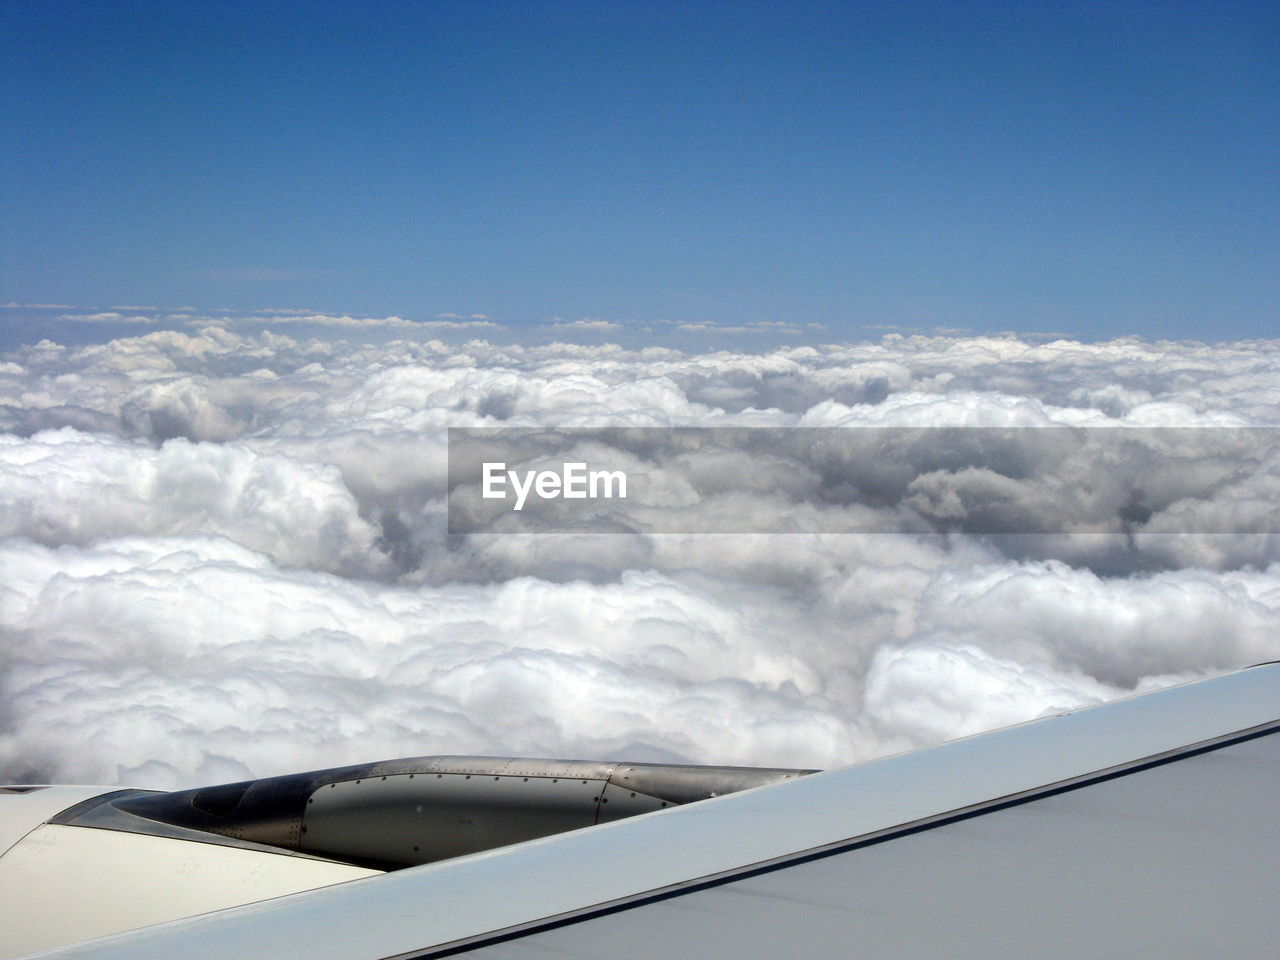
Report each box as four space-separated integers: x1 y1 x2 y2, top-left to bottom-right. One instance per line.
448 733 1280 960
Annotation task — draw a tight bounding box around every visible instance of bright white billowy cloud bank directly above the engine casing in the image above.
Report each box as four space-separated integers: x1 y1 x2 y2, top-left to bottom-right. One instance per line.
0 538 860 783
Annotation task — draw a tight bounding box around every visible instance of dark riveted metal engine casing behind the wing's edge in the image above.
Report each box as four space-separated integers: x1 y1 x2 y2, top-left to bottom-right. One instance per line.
107 756 813 869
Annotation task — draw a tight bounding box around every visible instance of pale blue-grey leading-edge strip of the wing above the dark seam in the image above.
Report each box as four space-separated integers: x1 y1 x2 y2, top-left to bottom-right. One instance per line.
45 664 1280 960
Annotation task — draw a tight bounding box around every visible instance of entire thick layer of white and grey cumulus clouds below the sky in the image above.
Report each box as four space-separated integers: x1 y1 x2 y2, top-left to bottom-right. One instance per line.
0 323 1280 787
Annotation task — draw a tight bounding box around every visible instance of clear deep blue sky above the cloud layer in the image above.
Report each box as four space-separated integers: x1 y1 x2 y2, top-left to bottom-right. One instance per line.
0 0 1280 339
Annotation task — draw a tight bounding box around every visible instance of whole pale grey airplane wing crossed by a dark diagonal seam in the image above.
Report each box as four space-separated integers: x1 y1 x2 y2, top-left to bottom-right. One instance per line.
0 664 1280 960
